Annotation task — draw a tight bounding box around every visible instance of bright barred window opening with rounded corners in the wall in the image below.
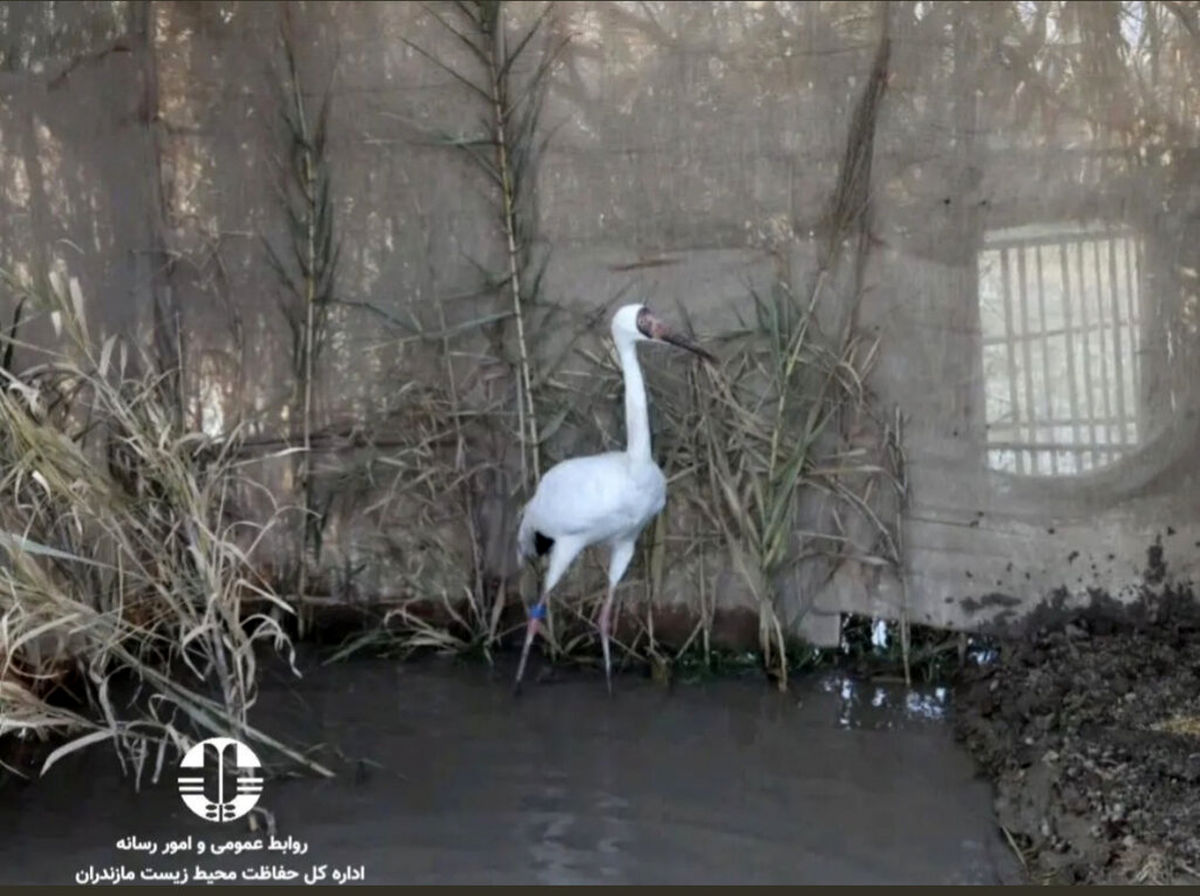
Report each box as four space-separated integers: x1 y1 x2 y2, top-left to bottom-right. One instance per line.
979 223 1142 476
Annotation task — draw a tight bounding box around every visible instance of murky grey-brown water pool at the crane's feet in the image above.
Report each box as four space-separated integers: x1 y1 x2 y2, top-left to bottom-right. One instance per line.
0 661 1016 884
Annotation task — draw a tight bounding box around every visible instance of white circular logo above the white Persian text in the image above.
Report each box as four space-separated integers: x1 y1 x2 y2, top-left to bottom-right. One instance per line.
178 738 263 822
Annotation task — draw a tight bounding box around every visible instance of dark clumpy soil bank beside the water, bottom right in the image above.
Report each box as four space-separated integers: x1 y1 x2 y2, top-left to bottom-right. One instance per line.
955 590 1200 884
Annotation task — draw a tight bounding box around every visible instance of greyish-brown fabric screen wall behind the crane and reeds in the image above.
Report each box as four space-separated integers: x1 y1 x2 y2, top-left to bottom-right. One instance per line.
0 2 1200 642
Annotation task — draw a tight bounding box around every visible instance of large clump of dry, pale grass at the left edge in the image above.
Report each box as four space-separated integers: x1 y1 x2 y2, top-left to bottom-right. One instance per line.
0 275 319 781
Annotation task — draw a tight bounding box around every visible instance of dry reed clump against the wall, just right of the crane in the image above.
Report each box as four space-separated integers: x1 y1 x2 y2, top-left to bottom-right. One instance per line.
662 273 896 686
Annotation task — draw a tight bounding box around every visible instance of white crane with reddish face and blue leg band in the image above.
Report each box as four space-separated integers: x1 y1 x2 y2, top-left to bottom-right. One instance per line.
514 305 715 692
